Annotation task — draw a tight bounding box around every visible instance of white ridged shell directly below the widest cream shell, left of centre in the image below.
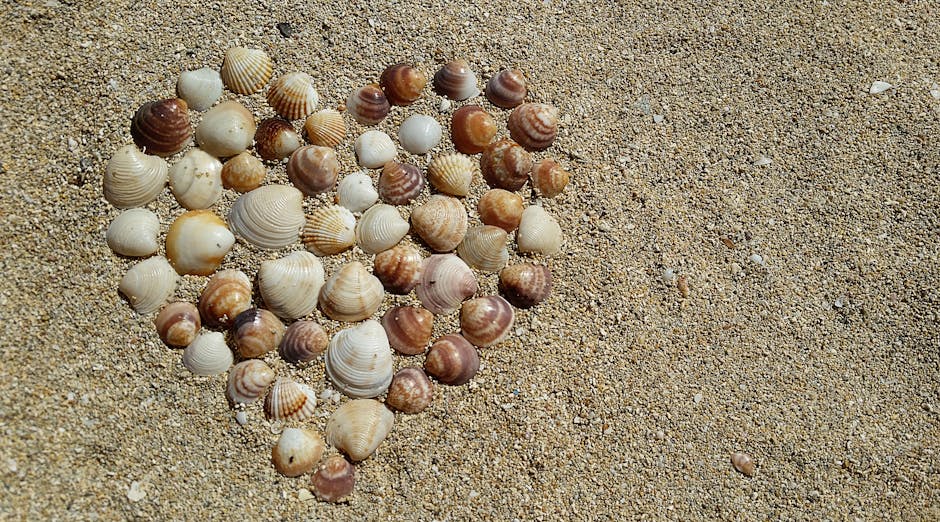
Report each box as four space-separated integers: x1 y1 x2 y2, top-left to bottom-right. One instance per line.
258 252 324 319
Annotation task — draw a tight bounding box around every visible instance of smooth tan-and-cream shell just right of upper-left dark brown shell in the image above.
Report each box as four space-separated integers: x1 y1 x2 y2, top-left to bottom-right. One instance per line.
196 101 255 158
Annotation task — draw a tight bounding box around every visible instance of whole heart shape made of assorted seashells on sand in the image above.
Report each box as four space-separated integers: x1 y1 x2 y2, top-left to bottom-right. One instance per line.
104 47 569 501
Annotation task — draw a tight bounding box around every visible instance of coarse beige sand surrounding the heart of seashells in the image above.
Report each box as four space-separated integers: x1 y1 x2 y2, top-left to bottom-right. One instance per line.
0 0 940 520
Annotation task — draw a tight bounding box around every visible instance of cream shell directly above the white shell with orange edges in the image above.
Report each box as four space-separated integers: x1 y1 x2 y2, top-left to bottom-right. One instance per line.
170 149 222 210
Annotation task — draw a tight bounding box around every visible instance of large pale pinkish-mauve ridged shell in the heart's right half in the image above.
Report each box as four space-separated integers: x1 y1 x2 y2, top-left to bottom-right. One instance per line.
415 254 477 315
